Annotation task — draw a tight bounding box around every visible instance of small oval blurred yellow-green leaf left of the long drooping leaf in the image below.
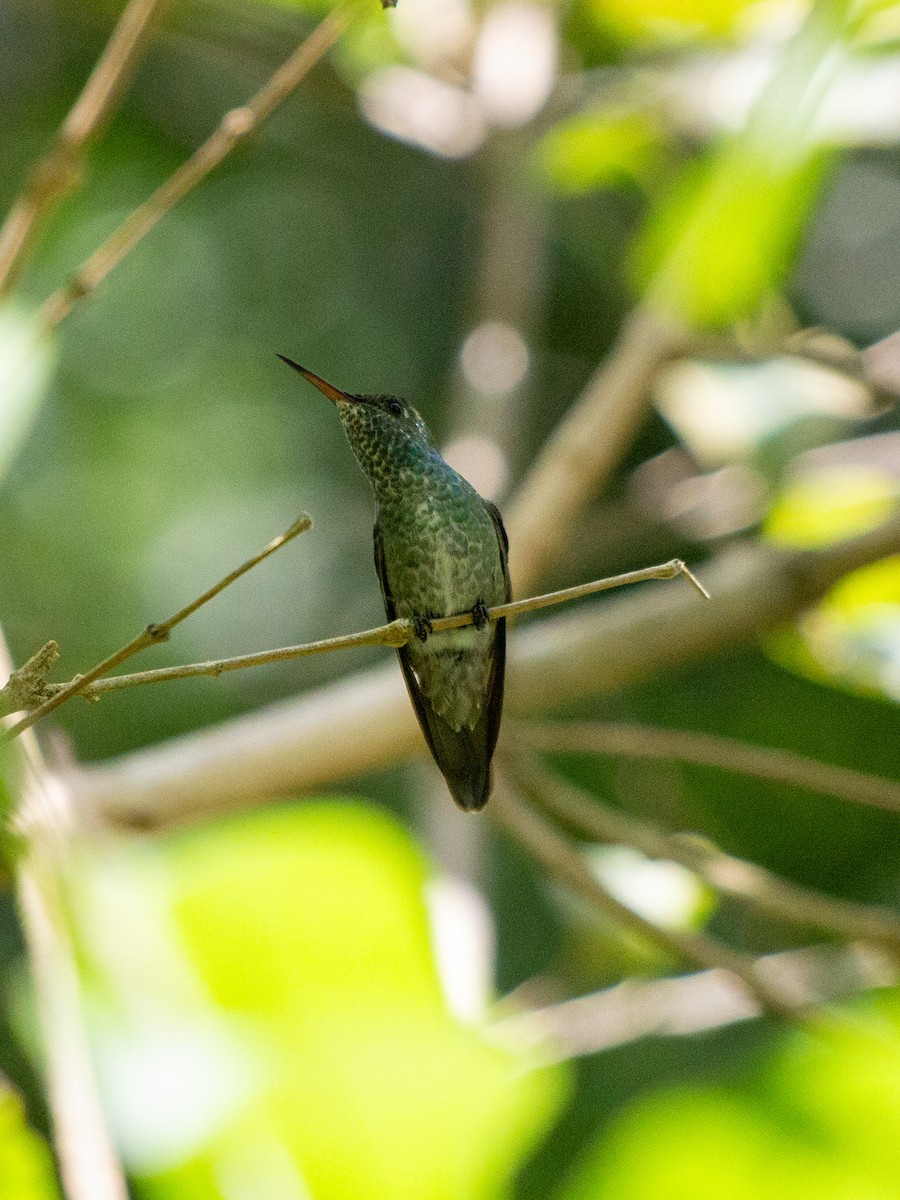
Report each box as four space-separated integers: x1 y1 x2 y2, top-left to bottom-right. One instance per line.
539 113 661 194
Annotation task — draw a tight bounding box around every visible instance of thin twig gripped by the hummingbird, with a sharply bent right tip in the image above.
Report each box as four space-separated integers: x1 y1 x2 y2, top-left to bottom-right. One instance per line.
22 558 709 710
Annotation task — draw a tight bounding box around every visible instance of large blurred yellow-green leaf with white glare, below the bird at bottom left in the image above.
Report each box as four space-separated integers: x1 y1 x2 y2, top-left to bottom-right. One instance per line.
79 802 565 1200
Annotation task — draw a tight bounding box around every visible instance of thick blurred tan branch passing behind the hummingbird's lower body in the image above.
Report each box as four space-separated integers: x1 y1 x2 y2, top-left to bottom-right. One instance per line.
67 517 900 827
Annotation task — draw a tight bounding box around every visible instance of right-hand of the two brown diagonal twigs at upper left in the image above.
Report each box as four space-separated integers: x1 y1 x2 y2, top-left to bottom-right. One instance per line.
41 0 361 329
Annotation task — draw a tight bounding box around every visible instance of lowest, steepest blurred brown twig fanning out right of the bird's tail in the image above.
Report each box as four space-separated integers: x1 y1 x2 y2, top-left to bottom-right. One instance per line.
488 788 800 1019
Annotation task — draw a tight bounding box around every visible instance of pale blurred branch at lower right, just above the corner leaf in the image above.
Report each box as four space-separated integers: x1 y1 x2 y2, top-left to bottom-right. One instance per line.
492 946 898 1062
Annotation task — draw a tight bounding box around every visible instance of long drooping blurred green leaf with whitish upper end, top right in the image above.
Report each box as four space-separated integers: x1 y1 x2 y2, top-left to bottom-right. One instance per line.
635 0 858 326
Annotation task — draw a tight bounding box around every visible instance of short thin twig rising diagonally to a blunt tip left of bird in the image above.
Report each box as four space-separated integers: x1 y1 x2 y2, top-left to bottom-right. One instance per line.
0 512 314 742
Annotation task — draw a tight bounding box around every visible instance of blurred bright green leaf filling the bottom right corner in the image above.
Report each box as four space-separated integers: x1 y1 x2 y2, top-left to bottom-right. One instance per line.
557 997 900 1200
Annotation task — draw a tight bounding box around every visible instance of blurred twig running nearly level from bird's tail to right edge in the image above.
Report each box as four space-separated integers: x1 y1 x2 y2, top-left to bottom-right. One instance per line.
522 721 900 812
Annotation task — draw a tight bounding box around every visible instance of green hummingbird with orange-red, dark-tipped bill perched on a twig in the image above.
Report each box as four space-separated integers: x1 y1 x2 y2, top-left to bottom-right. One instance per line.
278 354 511 811
